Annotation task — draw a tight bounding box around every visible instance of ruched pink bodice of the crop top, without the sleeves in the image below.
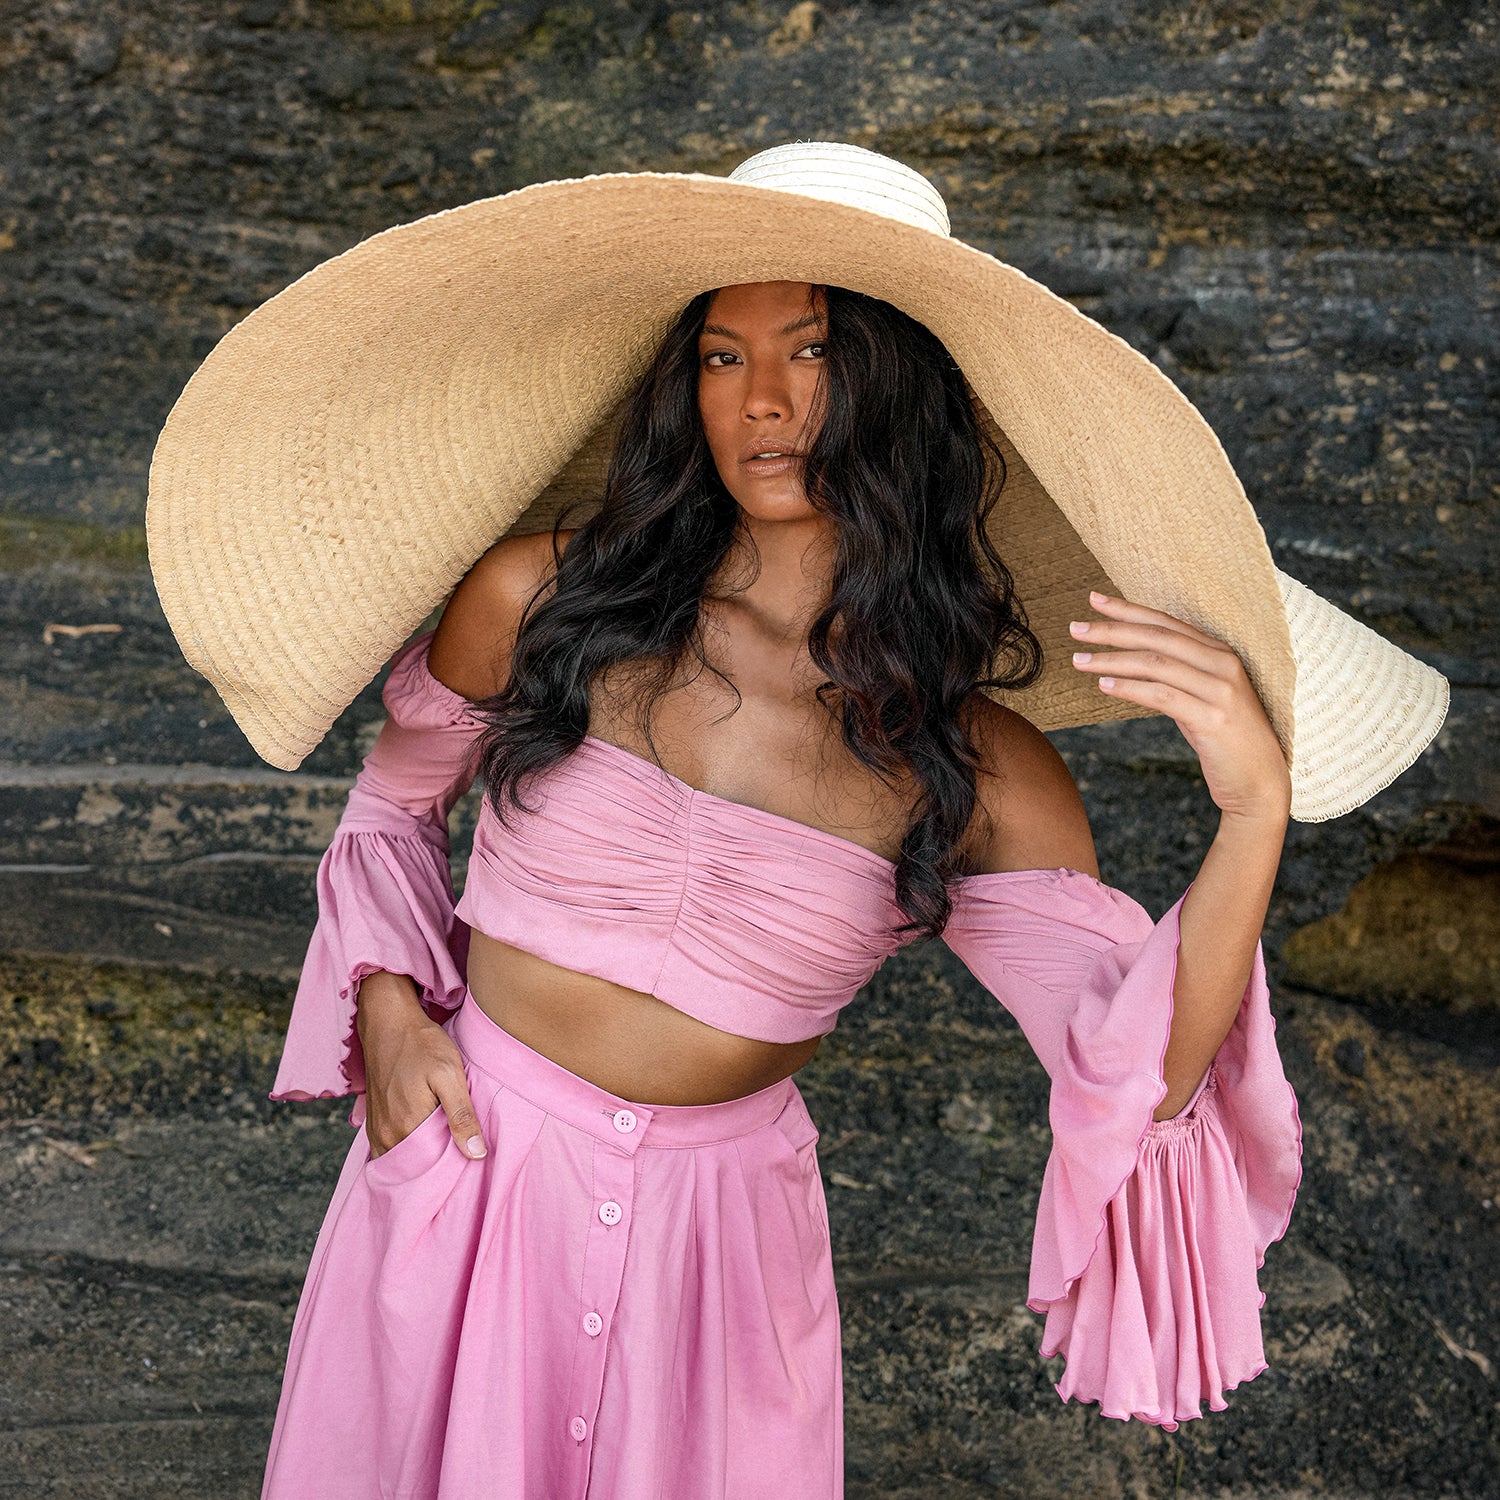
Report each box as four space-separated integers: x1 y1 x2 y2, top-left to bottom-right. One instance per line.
458 735 906 1043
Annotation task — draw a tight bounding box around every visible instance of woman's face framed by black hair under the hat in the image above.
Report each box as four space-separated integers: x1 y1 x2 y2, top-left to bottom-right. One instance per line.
698 282 828 521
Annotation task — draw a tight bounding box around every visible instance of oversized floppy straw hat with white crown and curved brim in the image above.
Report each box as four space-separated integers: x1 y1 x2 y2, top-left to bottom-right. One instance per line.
146 143 1448 822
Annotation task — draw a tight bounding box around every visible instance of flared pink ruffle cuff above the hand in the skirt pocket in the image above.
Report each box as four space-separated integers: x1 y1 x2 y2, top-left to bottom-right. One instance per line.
272 830 468 1124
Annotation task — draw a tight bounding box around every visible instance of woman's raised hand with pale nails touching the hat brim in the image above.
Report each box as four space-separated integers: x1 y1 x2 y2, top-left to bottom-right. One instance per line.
1071 594 1292 821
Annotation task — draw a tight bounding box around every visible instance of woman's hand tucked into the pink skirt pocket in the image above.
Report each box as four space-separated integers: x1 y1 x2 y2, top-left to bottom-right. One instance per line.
356 972 488 1158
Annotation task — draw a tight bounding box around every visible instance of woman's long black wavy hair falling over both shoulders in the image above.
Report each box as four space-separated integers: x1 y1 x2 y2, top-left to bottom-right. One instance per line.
476 287 1043 936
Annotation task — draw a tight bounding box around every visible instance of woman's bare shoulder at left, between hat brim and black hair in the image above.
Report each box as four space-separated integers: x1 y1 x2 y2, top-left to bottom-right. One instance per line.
428 531 575 699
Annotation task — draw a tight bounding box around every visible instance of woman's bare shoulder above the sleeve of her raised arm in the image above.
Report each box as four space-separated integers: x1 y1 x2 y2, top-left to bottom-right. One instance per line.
969 693 1100 876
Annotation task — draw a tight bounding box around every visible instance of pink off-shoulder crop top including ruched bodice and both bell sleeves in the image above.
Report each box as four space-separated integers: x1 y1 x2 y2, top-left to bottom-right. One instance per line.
272 633 1302 1430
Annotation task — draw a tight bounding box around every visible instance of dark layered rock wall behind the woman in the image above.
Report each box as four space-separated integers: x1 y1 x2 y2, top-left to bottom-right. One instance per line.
0 0 1500 1496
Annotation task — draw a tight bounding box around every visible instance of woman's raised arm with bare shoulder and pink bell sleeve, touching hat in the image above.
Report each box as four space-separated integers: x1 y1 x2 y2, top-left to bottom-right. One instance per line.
944 603 1302 1430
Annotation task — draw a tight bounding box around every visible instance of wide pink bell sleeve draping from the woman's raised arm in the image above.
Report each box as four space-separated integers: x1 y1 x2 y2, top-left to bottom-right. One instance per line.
944 867 1302 1431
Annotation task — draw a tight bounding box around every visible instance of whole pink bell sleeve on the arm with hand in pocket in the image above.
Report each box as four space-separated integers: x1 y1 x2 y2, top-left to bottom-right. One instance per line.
272 632 483 1125
